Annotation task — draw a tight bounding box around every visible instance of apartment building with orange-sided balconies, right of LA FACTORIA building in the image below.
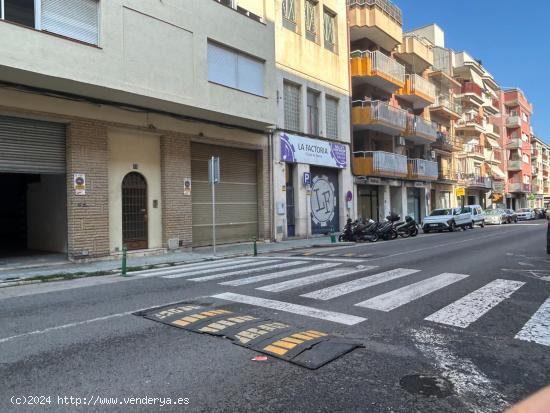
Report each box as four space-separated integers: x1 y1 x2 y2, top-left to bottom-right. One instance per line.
348 0 438 220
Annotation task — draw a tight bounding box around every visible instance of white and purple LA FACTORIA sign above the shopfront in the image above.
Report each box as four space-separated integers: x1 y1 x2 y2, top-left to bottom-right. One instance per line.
281 133 348 169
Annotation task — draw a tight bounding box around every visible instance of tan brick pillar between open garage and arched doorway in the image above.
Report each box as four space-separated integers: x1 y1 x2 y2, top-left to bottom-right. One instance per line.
67 120 109 259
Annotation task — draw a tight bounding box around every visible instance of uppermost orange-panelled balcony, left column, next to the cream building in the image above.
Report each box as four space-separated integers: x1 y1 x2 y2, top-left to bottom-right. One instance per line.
350 50 405 93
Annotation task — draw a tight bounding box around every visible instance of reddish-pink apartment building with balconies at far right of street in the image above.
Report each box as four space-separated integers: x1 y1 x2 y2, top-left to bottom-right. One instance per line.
500 88 533 209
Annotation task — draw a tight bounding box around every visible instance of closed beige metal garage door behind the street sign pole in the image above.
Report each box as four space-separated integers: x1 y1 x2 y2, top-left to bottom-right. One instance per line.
191 143 258 246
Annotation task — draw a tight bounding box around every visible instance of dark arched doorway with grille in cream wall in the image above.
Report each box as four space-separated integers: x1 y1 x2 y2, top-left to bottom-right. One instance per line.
122 172 148 250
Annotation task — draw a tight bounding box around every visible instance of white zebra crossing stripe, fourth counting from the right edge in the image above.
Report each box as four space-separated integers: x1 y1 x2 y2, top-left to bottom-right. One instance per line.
301 268 420 300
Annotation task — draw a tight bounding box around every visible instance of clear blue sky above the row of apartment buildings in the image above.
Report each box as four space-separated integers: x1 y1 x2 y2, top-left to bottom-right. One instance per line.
393 0 550 144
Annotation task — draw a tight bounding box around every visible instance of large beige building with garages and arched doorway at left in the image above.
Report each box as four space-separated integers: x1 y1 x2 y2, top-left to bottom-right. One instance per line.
0 0 276 259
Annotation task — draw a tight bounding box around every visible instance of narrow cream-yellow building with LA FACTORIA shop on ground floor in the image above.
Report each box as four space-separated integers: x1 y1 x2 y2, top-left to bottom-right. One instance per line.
272 0 355 240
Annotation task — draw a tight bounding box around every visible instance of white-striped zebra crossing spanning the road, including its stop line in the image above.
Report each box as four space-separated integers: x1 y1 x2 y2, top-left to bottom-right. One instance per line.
136 257 550 346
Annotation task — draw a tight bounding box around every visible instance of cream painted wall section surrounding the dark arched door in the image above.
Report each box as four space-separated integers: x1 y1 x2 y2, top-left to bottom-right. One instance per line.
108 129 162 252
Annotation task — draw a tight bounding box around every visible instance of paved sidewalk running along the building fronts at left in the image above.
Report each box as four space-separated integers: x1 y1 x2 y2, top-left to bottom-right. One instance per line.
0 236 343 285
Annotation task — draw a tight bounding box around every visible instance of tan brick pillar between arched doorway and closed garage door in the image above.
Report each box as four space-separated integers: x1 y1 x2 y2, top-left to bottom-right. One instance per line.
160 135 193 248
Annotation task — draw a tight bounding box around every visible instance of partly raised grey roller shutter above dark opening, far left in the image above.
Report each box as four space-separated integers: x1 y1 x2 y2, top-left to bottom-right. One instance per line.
0 116 65 174
